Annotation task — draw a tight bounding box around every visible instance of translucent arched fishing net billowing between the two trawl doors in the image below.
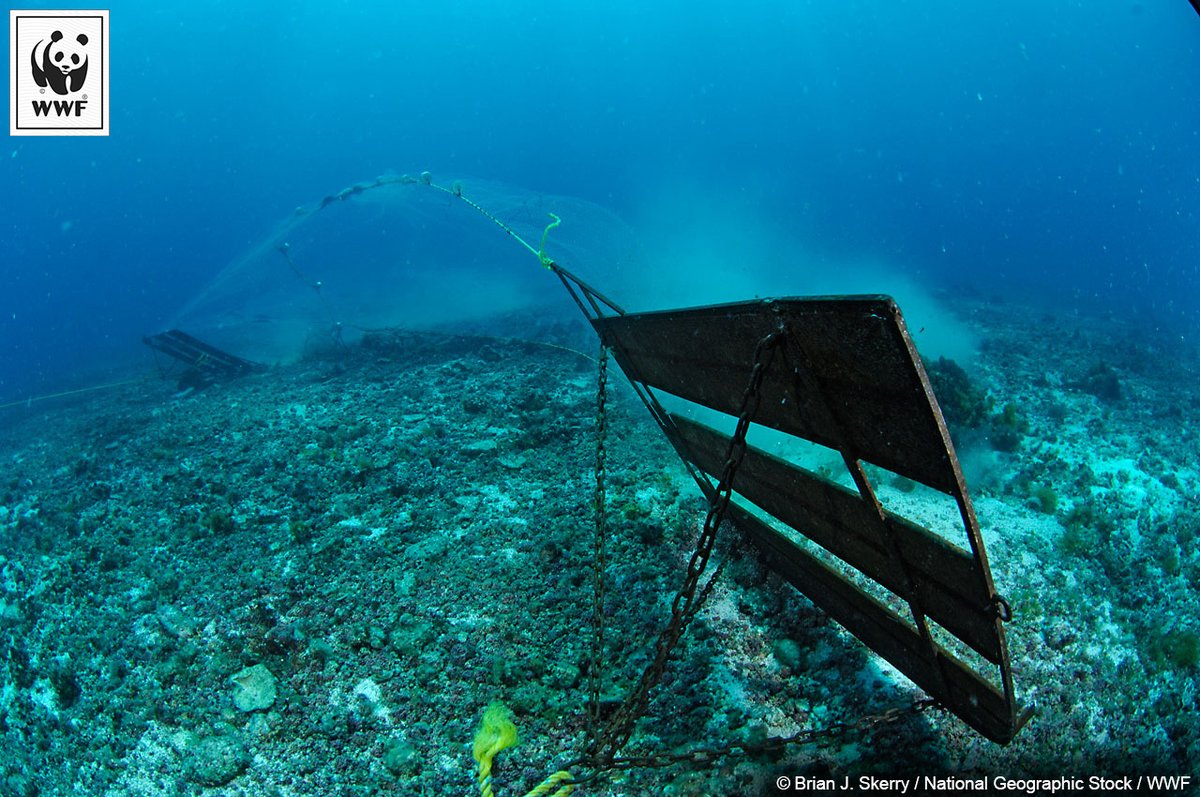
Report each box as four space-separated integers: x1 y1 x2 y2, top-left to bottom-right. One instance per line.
170 174 640 362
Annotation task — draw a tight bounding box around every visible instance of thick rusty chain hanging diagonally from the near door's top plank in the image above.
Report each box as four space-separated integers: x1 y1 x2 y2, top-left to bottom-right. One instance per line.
587 331 781 768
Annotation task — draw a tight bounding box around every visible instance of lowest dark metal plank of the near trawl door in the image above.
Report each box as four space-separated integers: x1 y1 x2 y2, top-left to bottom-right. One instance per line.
730 504 1020 744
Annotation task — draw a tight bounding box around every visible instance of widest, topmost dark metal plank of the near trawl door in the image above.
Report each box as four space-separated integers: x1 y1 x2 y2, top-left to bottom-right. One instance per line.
593 296 959 493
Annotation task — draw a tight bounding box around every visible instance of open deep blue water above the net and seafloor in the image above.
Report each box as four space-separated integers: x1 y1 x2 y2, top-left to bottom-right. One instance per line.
0 0 1200 403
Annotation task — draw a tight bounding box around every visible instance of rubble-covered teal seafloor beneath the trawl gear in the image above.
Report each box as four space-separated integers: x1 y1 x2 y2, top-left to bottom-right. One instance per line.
0 295 1200 797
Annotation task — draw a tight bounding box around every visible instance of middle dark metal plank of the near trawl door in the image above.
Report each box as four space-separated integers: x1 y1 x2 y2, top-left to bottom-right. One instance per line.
671 414 1003 664
